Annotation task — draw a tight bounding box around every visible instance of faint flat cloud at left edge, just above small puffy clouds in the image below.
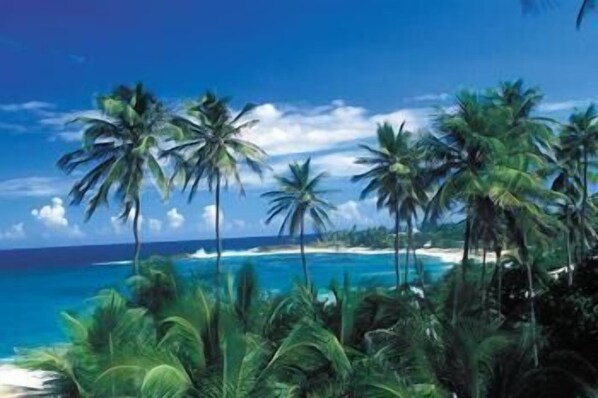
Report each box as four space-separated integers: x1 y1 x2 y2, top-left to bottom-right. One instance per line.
0 177 71 198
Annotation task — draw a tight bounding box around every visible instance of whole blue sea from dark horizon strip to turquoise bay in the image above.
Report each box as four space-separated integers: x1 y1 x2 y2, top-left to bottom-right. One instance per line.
0 236 451 358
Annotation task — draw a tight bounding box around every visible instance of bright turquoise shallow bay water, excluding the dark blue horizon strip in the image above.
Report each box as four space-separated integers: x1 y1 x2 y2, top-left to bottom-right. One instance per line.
0 239 450 357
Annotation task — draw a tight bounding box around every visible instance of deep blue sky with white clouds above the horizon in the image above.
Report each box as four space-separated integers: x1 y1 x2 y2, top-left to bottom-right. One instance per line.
0 0 598 248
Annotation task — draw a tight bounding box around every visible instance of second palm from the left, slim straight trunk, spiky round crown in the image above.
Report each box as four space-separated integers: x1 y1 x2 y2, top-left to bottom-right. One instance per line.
164 91 266 276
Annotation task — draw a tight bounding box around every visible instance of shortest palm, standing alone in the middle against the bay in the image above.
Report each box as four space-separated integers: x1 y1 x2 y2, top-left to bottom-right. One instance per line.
262 158 335 288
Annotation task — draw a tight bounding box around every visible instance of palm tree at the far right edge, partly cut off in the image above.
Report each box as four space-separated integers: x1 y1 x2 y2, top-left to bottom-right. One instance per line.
560 104 598 256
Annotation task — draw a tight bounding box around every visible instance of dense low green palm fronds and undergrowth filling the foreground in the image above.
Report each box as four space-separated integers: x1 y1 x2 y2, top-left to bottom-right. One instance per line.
20 253 598 398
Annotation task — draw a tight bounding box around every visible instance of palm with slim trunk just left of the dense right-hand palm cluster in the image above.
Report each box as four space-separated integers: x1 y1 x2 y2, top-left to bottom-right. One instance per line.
351 122 421 292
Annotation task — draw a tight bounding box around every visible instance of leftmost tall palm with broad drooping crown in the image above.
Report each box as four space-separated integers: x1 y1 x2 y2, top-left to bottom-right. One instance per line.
58 83 172 271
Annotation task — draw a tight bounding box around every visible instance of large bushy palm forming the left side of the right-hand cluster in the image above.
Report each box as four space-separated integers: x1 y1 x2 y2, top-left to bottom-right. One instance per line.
420 91 508 324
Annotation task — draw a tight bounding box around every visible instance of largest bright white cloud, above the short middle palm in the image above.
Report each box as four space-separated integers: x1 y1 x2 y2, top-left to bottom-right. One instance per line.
244 101 430 156
